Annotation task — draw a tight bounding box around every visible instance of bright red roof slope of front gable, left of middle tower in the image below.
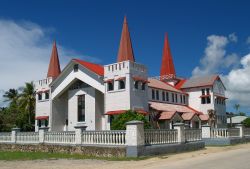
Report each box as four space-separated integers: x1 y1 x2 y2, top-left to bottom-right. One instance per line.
72 59 104 76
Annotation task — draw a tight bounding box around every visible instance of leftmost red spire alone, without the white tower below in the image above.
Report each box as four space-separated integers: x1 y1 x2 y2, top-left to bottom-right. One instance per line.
47 41 61 78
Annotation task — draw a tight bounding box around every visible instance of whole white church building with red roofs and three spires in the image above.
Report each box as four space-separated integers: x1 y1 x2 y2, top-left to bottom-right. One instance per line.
35 17 227 131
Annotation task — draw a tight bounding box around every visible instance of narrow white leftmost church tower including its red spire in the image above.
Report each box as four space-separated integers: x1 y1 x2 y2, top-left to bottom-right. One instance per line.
35 42 61 131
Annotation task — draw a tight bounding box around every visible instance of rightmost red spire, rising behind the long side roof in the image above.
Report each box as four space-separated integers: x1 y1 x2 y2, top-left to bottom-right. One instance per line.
161 33 175 79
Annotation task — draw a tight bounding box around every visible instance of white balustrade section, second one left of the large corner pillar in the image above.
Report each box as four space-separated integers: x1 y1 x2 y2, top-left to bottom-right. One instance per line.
44 131 75 144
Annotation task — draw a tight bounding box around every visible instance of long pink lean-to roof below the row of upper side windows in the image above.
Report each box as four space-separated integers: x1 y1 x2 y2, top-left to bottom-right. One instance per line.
149 102 201 114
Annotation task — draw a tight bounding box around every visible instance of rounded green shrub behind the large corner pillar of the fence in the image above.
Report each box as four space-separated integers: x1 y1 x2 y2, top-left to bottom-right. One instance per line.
111 110 150 130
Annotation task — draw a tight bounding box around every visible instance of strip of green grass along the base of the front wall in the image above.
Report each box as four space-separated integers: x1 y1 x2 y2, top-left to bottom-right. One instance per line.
0 151 148 161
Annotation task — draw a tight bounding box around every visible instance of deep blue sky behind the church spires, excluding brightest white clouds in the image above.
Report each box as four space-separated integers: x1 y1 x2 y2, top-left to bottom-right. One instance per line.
0 0 250 111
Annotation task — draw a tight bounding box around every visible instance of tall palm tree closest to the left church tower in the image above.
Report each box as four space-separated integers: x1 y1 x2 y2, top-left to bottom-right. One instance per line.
19 82 36 124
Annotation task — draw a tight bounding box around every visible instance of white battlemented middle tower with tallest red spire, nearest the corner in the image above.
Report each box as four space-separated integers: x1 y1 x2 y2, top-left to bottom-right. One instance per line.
104 17 148 115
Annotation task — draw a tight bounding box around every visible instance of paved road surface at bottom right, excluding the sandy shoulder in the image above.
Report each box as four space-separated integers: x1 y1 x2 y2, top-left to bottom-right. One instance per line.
146 148 250 169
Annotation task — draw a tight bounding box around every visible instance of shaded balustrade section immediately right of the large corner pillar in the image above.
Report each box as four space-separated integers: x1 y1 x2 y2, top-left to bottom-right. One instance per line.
144 129 178 145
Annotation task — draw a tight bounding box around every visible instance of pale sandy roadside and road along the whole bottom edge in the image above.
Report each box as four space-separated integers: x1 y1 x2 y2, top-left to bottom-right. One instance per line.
0 144 250 169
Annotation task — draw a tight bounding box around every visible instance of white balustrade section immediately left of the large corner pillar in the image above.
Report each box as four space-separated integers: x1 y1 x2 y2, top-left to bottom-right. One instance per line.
81 130 126 145
